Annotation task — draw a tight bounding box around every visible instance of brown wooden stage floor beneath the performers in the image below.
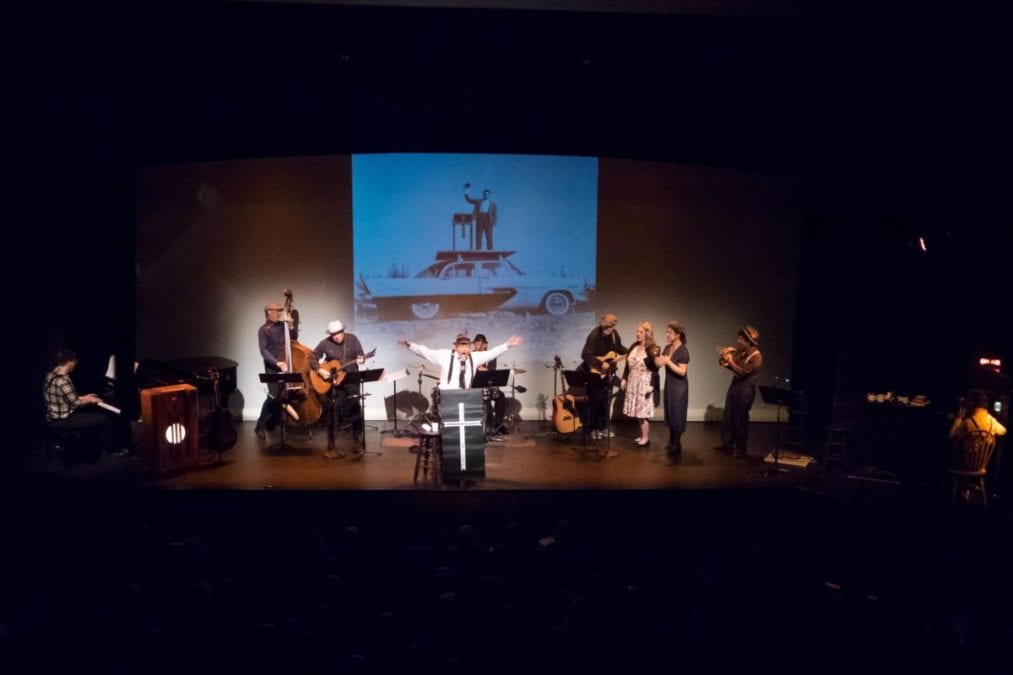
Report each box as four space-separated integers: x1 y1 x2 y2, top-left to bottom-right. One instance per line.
15 415 822 491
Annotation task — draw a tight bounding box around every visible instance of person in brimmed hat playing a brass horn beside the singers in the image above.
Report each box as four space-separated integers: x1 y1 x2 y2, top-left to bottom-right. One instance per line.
718 324 763 457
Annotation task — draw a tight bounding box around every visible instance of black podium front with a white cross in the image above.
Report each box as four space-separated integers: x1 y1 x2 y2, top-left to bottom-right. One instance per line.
440 389 485 480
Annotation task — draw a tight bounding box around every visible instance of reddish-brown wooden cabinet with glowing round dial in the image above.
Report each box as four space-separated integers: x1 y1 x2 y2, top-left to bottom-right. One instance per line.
141 384 200 475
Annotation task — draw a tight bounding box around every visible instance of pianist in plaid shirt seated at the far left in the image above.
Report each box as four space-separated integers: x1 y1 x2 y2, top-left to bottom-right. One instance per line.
43 350 128 455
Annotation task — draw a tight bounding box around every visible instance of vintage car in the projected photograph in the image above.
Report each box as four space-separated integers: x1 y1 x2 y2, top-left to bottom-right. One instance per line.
357 250 592 319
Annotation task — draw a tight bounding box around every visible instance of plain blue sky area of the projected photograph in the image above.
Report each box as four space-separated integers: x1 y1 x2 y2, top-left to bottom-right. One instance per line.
352 154 598 318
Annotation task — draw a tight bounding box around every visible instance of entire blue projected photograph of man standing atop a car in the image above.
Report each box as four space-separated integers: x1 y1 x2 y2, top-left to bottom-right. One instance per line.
352 154 598 324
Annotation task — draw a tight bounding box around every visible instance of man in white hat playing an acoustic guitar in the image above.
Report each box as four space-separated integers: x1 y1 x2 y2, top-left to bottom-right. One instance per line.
310 319 366 459
